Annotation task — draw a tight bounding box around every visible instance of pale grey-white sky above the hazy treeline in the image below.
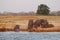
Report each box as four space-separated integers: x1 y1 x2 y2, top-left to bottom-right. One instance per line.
0 0 60 12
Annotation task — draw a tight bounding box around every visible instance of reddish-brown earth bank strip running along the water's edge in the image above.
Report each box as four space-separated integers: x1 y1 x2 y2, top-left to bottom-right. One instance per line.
0 26 60 32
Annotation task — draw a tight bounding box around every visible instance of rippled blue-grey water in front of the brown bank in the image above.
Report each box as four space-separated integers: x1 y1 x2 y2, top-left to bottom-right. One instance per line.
0 32 60 40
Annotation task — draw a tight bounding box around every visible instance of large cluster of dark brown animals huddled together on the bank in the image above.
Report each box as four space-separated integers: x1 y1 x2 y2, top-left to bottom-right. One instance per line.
28 19 54 29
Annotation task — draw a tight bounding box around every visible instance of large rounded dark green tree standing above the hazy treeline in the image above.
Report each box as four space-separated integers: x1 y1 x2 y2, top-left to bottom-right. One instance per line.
37 4 50 15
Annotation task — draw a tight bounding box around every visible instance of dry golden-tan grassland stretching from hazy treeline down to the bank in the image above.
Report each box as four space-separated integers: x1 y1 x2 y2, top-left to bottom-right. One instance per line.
0 16 60 31
